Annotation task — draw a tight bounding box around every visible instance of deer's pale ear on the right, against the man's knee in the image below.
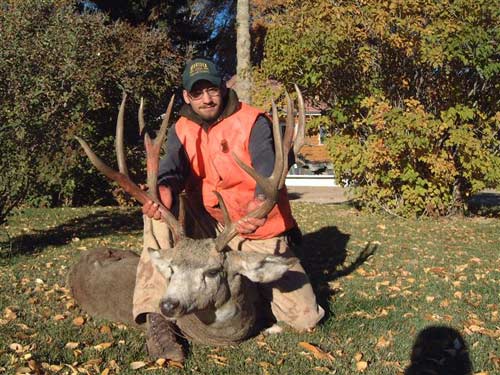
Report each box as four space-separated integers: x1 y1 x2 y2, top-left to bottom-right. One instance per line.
228 251 298 283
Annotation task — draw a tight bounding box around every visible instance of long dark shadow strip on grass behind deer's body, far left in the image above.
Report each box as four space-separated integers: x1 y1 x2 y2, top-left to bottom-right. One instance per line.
0 210 143 259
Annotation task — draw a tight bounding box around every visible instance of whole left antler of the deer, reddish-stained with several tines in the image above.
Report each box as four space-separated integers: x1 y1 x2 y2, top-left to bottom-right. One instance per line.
75 93 184 242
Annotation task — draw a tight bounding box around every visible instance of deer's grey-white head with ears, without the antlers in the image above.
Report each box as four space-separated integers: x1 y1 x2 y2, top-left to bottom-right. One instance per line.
149 239 297 323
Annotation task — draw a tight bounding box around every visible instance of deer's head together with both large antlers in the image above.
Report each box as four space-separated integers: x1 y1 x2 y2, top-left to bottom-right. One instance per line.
77 86 305 320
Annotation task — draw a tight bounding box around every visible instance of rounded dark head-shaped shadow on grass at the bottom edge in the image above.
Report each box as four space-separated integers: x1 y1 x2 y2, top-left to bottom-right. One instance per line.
405 326 472 375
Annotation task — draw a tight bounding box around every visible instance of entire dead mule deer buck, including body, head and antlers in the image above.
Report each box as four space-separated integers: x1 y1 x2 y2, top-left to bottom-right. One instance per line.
68 87 305 356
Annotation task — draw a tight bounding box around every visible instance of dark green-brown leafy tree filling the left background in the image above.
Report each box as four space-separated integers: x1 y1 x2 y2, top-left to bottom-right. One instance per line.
0 0 180 206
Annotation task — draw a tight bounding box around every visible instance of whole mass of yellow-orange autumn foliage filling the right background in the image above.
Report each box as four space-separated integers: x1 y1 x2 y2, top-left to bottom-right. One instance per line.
256 0 500 215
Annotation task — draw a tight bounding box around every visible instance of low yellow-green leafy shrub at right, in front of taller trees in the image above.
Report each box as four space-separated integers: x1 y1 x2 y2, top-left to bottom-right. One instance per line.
329 97 500 216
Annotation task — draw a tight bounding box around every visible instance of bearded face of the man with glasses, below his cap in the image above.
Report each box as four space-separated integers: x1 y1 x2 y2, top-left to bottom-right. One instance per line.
182 80 225 122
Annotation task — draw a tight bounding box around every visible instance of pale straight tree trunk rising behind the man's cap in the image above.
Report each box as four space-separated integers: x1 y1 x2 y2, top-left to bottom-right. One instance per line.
236 0 252 104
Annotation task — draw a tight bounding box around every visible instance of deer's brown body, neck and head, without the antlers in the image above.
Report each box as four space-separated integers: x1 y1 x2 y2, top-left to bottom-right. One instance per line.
68 238 296 345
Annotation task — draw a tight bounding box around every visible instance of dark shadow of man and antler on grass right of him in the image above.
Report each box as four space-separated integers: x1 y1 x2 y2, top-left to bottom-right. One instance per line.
295 227 377 315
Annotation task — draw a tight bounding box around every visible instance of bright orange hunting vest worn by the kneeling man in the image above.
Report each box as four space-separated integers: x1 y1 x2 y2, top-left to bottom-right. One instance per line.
175 103 295 239
